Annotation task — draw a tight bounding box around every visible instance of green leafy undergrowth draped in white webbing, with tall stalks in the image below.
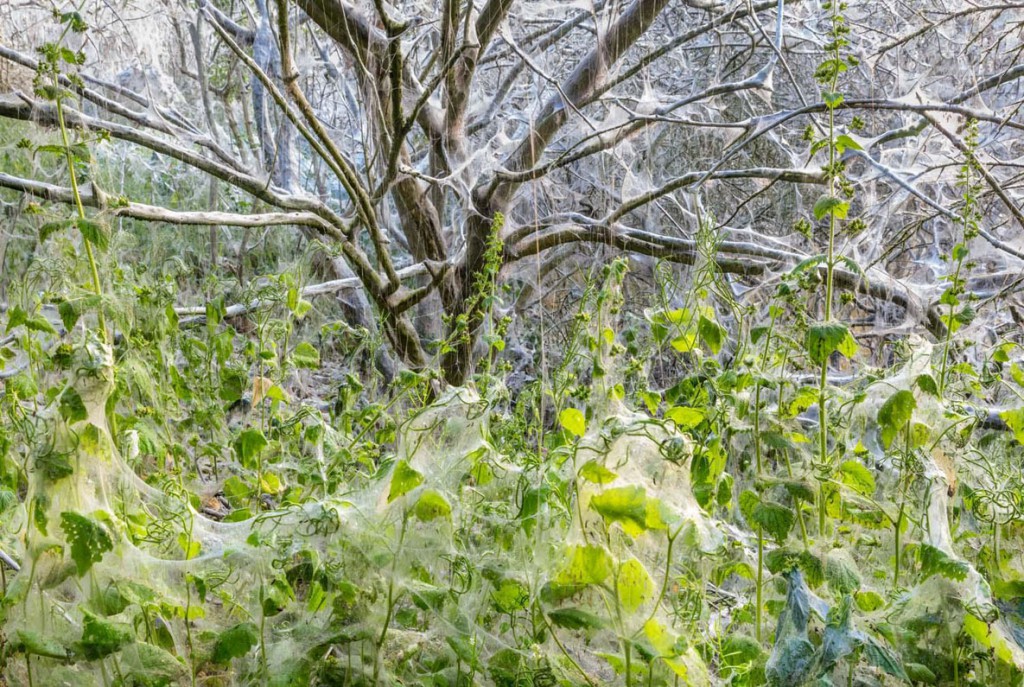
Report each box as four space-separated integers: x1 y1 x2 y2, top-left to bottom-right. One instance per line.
6 5 1024 687
